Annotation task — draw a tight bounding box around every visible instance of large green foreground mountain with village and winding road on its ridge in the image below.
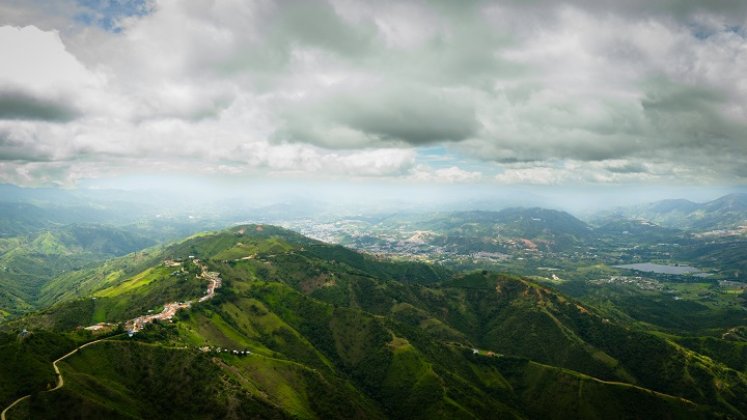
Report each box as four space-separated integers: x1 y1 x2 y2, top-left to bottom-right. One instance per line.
0 226 747 418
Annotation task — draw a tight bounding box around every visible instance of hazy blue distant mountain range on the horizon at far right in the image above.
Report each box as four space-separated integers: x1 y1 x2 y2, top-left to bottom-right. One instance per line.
613 193 747 231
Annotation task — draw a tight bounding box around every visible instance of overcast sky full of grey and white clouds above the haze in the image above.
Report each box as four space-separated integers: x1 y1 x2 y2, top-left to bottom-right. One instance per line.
0 0 747 187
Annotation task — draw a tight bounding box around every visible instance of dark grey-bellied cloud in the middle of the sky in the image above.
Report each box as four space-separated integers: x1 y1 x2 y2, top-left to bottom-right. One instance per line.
275 84 479 148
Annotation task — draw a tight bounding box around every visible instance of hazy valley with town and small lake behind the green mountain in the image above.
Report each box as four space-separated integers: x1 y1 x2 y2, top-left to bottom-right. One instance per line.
284 196 747 334
